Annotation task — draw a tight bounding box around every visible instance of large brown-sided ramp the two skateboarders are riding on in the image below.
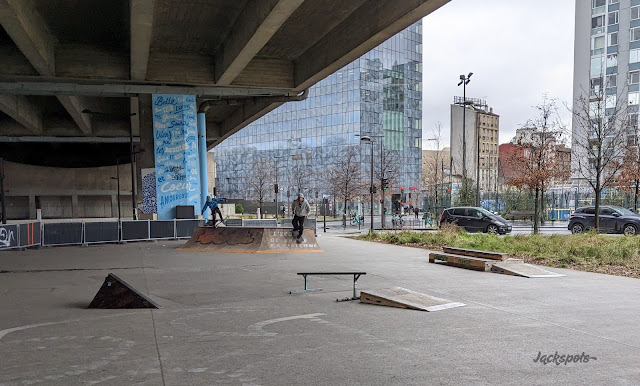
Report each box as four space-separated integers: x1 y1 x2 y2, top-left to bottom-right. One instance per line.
177 227 322 253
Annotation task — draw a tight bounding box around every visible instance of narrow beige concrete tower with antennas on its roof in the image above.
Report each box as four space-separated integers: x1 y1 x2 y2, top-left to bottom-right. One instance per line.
450 97 500 200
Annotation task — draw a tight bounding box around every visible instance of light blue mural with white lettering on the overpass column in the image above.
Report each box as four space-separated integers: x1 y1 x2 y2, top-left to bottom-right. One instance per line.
153 94 200 220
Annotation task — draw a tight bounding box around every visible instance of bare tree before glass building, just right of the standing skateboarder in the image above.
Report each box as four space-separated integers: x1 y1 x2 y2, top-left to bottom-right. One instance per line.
327 146 364 223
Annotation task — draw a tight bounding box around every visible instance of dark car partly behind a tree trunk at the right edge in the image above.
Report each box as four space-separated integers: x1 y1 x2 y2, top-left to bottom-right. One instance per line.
568 205 640 236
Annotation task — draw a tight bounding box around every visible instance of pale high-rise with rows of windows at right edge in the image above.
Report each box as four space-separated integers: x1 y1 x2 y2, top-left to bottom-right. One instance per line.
572 0 640 178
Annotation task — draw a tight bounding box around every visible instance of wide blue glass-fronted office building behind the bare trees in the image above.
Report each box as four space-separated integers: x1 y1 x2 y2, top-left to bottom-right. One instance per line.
214 22 422 211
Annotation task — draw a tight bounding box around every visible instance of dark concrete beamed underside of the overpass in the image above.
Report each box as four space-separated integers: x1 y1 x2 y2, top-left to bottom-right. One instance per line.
0 0 448 217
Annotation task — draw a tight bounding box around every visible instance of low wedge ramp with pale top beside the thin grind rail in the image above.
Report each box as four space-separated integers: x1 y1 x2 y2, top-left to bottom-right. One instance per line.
360 287 465 312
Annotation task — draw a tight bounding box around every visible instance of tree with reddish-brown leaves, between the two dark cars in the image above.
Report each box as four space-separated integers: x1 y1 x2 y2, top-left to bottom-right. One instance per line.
507 95 568 233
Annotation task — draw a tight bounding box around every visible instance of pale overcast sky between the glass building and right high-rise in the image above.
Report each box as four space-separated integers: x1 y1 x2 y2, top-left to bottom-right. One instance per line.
422 0 575 148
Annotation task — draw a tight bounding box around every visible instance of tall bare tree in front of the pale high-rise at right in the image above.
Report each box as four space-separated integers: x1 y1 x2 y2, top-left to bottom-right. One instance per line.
571 76 638 231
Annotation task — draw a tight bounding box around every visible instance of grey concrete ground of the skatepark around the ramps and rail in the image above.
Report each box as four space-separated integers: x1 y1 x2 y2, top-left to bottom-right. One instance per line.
0 232 640 385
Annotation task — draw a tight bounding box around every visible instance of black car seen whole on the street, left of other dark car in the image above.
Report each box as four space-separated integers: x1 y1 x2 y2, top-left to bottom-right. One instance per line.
440 206 511 234
